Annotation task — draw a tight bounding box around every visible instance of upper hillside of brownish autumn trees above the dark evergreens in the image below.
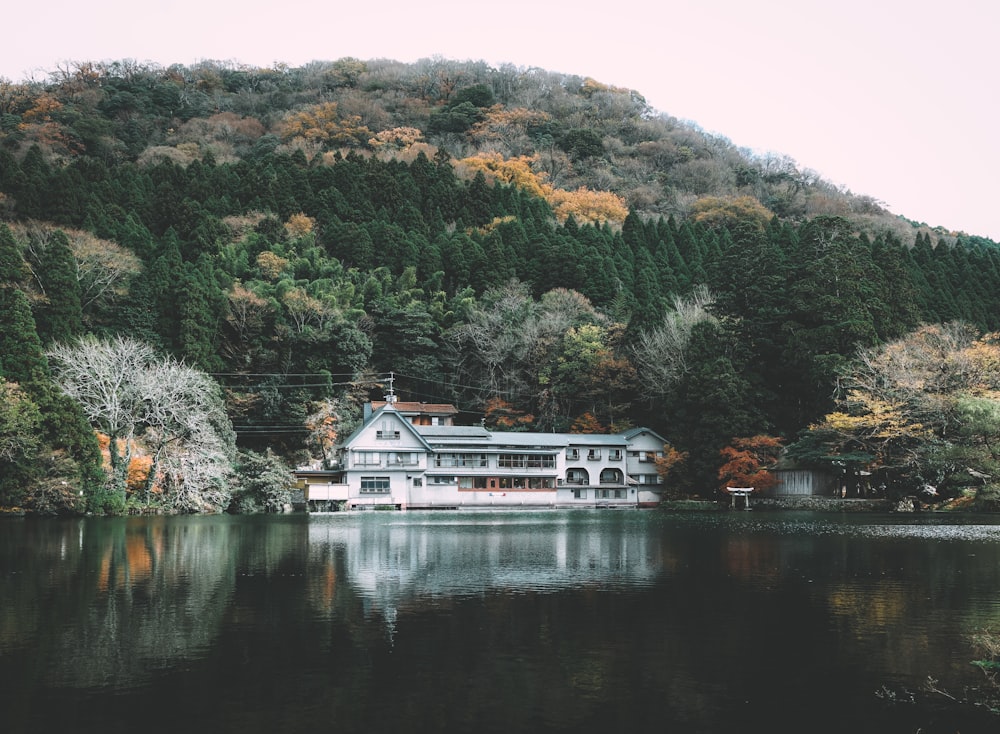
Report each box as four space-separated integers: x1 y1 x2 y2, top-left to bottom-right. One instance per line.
0 59 952 243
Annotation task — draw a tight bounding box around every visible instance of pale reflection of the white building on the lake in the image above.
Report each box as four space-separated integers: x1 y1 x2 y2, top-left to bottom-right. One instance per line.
309 512 662 609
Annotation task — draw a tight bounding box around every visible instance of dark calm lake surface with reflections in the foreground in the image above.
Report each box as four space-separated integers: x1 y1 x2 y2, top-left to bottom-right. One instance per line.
0 510 1000 734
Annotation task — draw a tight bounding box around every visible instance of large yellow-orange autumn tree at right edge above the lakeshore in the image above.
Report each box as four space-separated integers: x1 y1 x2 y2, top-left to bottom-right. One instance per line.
791 323 1000 500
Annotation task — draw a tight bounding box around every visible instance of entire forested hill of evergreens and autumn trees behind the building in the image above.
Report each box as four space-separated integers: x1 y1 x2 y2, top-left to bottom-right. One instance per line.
0 58 1000 513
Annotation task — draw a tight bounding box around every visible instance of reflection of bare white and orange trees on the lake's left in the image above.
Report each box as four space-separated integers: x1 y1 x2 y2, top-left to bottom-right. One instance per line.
0 518 304 687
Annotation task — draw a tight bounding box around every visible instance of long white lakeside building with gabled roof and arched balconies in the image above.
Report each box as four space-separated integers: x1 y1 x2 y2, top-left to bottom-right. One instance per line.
296 401 664 509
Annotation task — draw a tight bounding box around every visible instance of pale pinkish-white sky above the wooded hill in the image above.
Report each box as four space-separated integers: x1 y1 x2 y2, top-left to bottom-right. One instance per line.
7 0 1000 241
